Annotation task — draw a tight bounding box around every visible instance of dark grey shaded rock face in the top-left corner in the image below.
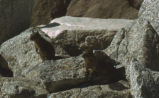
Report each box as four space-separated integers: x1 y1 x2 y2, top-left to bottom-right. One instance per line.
0 0 33 44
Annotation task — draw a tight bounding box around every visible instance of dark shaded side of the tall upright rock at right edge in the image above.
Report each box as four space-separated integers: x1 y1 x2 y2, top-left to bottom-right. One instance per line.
143 21 159 71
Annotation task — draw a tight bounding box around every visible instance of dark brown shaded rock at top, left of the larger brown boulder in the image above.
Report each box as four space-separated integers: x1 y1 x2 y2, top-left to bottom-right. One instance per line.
31 0 71 26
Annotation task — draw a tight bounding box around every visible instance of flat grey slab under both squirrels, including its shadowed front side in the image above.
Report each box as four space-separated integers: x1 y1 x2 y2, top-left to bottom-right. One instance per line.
26 56 124 92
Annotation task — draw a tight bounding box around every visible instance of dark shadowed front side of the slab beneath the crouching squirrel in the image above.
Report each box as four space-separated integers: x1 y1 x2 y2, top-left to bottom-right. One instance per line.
44 68 125 93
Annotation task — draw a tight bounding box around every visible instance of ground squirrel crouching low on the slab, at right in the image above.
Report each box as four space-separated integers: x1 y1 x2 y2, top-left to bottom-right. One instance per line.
82 49 117 77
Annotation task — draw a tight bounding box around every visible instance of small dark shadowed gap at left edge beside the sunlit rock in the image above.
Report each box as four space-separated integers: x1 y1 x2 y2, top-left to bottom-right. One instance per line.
0 55 13 77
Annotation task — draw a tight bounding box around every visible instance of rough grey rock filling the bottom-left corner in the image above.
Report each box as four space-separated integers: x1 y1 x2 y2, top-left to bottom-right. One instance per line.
0 78 47 98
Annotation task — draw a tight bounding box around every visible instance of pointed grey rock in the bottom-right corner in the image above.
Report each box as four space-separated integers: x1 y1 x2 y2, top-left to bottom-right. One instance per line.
129 58 159 98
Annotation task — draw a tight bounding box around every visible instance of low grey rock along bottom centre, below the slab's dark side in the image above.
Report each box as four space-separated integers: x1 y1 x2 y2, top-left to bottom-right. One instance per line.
48 81 133 98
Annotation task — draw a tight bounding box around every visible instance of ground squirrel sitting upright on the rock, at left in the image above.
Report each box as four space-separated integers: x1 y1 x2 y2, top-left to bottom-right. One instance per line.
30 28 55 61
